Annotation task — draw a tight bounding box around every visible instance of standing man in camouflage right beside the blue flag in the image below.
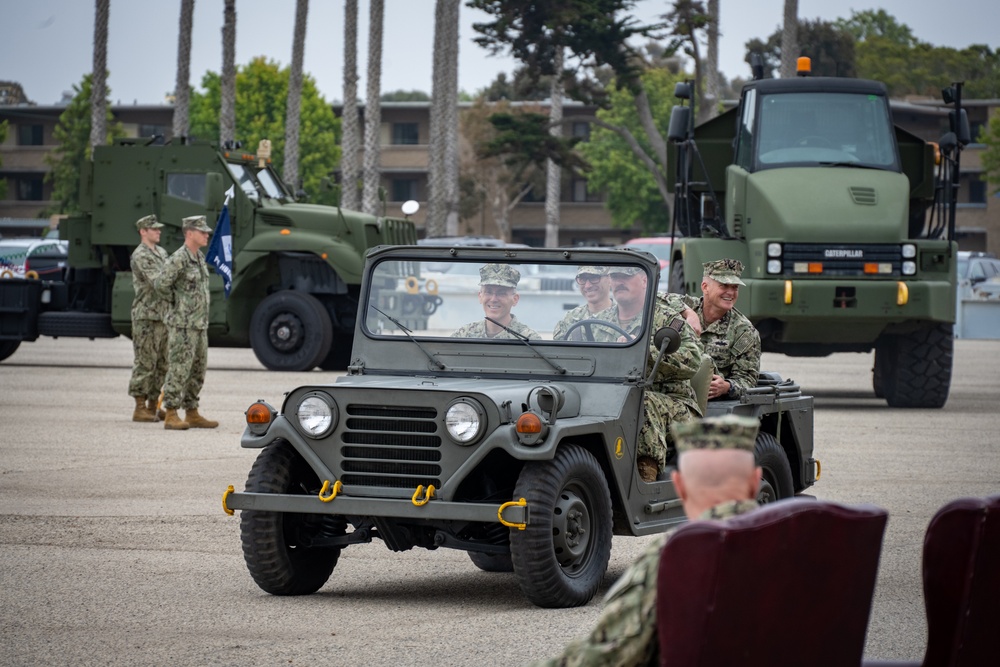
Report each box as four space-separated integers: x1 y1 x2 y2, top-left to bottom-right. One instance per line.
155 215 219 430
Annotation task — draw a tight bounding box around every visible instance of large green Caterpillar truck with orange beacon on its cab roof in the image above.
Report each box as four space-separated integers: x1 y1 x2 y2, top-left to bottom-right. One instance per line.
668 64 968 408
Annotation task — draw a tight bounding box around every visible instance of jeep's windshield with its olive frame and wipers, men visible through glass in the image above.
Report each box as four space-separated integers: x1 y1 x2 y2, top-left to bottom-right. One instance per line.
352 246 659 382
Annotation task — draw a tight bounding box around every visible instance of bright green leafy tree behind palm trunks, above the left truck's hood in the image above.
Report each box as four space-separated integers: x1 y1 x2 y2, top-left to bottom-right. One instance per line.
191 56 340 204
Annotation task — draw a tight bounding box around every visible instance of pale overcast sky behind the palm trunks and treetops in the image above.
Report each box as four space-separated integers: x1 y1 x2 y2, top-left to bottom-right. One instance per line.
0 0 1000 104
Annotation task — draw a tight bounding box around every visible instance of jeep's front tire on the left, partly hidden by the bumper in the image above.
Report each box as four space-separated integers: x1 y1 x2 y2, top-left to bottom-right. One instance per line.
240 440 347 595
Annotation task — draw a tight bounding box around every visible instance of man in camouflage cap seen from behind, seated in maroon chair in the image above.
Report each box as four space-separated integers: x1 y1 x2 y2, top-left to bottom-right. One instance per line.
534 415 761 667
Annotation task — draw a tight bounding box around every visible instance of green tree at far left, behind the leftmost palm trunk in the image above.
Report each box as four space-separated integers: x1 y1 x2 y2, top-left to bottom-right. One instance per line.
43 74 125 216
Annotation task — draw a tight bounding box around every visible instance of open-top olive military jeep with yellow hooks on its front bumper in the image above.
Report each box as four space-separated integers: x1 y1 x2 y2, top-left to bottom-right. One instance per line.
223 246 819 607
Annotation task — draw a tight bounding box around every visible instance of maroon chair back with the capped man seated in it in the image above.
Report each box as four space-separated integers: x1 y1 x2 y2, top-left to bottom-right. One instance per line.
656 499 887 667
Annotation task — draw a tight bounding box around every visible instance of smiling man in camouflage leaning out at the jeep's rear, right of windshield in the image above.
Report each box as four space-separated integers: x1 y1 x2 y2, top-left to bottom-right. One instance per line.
668 259 760 399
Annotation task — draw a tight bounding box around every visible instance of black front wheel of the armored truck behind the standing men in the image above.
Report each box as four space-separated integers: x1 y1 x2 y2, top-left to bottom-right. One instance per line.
250 290 333 371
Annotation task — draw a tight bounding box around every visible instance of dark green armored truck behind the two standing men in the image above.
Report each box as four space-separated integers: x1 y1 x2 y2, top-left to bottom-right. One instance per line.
0 139 416 371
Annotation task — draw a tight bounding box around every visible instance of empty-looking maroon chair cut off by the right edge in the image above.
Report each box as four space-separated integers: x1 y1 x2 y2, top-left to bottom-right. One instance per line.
865 496 1000 667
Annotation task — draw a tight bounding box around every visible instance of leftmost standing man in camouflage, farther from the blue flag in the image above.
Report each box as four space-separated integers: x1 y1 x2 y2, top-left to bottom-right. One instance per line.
128 215 170 422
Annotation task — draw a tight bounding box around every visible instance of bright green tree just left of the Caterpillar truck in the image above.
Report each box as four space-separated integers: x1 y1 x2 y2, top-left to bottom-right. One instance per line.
577 69 685 232
